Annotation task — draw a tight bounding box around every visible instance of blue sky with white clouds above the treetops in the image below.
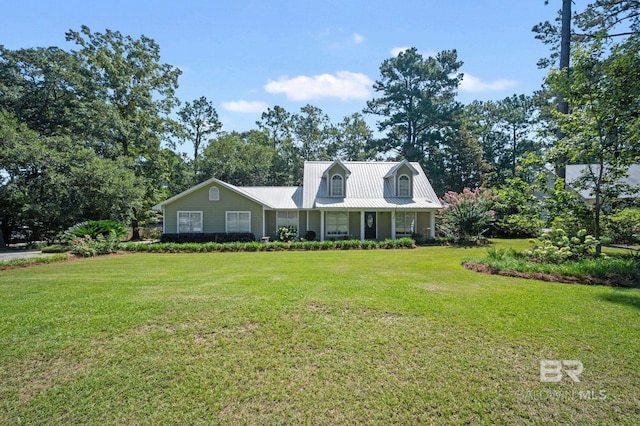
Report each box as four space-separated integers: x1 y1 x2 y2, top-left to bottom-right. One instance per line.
0 0 586 145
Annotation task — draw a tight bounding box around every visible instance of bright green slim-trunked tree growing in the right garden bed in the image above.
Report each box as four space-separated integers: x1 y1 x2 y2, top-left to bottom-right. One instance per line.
548 38 640 246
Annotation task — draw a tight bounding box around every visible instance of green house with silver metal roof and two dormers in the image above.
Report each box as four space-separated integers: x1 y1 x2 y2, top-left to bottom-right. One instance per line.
154 160 442 241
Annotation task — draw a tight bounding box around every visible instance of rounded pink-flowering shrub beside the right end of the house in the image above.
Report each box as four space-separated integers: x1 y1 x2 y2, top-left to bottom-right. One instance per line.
439 188 493 242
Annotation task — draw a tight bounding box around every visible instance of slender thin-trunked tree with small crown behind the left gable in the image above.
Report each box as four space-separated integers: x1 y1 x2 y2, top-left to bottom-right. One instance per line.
178 96 222 176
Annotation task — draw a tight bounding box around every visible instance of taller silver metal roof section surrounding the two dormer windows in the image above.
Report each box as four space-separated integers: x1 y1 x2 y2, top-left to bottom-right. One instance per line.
302 161 442 209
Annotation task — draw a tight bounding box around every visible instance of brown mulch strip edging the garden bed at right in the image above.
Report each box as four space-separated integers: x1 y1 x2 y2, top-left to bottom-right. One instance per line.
462 262 640 287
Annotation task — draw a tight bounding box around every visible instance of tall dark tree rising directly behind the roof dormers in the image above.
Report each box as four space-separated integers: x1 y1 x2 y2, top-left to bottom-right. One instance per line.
365 48 462 161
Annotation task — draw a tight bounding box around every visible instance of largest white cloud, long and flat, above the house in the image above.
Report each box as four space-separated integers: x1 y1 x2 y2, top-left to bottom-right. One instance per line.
264 71 373 101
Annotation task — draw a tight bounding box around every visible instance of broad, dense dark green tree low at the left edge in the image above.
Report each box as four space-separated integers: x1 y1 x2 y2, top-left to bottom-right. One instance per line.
0 113 142 241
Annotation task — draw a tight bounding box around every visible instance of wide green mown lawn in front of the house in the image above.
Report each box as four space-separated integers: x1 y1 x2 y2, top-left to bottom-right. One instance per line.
0 242 640 425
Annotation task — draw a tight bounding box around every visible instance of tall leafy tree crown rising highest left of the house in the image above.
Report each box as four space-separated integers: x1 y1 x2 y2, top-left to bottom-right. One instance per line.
66 25 181 158
